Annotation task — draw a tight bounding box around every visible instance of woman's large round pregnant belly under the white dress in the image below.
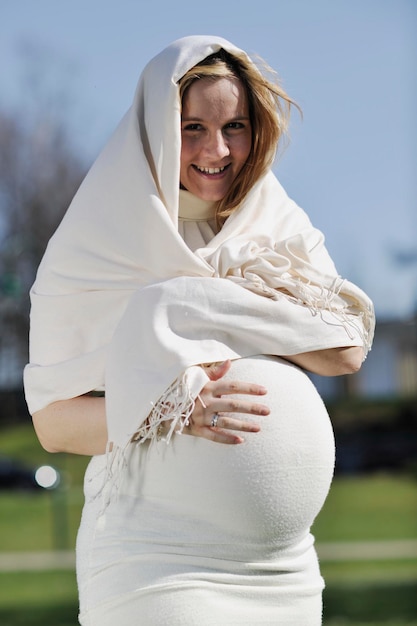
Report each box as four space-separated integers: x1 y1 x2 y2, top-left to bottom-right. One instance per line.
118 357 334 546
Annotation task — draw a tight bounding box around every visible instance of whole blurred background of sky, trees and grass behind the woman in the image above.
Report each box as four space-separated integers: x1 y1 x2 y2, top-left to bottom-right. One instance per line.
0 0 417 626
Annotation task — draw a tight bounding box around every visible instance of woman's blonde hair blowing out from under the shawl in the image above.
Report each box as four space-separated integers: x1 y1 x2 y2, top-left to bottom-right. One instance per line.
178 49 299 225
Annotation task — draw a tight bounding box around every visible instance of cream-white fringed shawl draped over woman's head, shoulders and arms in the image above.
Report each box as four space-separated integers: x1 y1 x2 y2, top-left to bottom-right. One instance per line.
24 36 374 446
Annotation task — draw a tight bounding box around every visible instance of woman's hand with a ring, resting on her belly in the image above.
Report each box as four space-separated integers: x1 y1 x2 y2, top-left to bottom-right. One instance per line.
182 361 270 444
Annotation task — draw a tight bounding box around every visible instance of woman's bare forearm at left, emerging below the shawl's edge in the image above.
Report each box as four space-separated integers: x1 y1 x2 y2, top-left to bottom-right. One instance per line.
33 396 107 456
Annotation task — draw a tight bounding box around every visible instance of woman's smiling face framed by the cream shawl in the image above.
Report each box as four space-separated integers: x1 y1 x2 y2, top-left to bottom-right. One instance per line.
180 78 252 201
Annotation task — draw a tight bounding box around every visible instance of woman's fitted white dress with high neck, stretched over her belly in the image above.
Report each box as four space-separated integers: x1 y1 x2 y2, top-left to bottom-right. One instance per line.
77 193 334 626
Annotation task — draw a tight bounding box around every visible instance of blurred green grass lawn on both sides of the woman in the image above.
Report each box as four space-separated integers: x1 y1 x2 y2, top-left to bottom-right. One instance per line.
0 426 417 626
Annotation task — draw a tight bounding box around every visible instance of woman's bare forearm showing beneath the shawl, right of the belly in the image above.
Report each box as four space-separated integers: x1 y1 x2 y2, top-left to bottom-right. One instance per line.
285 346 363 376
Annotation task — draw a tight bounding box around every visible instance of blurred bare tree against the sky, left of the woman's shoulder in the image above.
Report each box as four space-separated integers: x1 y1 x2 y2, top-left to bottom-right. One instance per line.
0 100 85 387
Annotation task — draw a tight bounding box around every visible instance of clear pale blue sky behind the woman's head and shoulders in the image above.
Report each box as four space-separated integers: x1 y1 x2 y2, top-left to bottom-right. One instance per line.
0 0 417 318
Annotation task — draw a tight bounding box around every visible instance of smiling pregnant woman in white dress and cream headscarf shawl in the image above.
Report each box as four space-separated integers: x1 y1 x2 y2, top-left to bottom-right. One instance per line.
25 36 374 626
